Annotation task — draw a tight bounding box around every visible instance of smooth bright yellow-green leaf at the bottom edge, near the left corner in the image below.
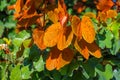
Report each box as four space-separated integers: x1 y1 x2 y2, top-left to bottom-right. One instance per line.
10 65 22 80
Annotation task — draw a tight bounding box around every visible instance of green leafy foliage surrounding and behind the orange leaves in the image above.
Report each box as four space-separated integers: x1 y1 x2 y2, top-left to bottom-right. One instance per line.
0 0 120 80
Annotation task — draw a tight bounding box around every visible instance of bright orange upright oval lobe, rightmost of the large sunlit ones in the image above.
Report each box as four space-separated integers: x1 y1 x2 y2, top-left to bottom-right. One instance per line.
81 16 95 43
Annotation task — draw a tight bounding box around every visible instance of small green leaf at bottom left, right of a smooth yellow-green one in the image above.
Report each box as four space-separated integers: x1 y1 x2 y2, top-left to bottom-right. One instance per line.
21 66 31 79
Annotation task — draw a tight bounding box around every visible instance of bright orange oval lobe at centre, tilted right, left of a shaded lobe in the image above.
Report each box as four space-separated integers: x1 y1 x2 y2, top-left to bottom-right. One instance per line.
43 23 62 47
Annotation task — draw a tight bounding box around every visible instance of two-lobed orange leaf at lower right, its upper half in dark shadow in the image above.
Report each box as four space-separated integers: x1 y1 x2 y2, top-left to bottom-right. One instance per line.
74 39 102 59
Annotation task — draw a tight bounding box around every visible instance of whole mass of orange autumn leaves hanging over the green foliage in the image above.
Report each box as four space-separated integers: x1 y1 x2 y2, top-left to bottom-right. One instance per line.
9 0 117 70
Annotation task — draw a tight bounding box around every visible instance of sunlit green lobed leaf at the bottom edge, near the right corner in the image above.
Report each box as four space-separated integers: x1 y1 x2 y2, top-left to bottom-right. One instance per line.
95 64 113 80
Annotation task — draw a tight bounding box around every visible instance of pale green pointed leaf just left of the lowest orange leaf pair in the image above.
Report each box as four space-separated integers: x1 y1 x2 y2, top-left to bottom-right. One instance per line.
33 56 45 72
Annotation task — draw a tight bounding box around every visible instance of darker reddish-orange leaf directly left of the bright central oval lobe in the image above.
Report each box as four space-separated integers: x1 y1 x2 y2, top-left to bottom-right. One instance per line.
32 28 46 50
